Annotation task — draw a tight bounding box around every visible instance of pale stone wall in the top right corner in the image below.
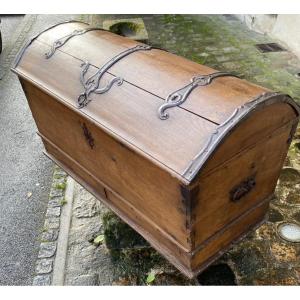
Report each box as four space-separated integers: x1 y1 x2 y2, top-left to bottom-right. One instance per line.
237 15 300 57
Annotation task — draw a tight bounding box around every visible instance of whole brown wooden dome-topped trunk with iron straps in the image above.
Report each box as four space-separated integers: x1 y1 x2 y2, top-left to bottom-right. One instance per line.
13 22 299 277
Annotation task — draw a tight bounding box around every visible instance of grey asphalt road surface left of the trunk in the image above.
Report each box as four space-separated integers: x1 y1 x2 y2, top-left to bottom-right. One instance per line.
0 15 79 285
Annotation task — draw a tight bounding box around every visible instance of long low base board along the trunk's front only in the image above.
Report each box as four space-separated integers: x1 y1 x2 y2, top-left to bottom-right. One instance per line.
43 138 192 277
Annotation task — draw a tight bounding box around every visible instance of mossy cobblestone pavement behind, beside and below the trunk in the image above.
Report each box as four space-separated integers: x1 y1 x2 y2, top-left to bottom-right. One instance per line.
57 15 300 285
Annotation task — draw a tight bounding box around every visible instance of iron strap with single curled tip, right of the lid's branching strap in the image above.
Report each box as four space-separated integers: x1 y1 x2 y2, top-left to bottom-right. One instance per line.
158 72 238 120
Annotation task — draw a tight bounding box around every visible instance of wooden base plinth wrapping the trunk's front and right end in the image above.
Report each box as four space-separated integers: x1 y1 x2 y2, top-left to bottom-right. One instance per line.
39 140 269 278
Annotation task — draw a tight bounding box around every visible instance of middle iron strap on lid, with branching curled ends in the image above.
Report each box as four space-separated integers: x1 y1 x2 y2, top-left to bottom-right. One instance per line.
78 45 152 108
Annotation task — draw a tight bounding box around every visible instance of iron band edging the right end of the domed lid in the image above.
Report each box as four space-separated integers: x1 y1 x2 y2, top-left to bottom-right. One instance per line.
183 92 300 181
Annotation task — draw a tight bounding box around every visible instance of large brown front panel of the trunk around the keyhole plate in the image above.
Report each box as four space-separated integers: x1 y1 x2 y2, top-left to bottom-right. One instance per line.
23 78 190 249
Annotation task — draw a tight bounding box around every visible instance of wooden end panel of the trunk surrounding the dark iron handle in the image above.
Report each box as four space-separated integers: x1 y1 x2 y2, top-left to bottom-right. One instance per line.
193 122 293 247
